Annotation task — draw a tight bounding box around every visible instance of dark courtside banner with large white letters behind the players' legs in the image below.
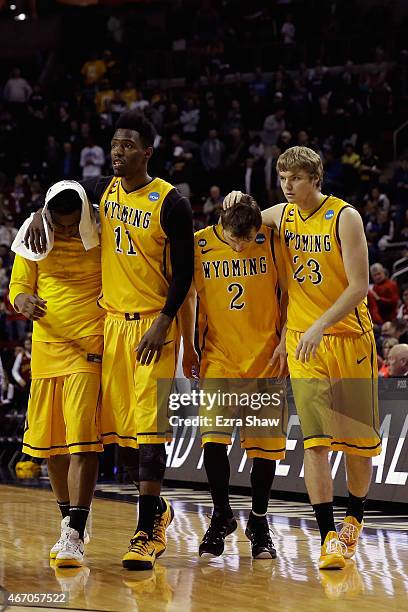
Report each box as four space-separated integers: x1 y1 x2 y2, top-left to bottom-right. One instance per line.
166 378 408 503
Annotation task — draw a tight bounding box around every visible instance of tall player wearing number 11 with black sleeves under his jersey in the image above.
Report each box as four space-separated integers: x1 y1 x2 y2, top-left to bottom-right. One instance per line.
26 111 194 570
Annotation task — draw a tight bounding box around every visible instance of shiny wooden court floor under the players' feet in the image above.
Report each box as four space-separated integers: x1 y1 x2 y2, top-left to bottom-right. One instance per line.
0 485 408 612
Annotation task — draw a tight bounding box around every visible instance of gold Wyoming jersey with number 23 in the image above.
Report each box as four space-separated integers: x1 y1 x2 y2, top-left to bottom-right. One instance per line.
279 196 372 335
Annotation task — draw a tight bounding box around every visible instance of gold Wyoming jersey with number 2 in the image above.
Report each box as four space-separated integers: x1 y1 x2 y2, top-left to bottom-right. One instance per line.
194 225 280 371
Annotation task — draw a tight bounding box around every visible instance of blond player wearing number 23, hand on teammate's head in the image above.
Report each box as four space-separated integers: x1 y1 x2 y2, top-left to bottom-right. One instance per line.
227 147 381 569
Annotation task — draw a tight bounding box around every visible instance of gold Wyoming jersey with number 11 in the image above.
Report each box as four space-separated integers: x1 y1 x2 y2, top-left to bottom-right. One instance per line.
99 178 174 315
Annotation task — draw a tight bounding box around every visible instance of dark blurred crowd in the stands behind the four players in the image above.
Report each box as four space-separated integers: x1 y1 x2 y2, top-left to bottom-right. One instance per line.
0 0 408 430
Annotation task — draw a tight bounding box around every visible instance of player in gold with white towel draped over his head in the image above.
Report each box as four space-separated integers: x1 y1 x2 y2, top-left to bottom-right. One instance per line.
10 183 104 567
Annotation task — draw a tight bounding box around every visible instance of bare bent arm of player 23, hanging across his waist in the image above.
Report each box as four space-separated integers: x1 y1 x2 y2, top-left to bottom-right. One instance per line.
296 208 368 362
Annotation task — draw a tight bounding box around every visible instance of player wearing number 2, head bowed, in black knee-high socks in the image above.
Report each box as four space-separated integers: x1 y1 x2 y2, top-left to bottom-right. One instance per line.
180 196 286 559
